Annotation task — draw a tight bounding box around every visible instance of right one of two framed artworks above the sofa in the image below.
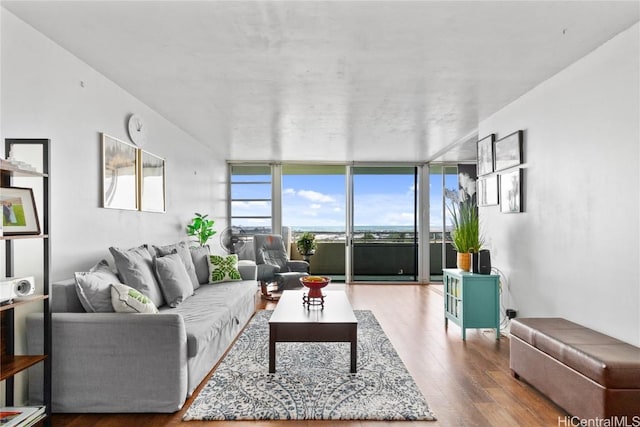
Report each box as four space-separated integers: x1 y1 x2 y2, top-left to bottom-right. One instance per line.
139 149 166 213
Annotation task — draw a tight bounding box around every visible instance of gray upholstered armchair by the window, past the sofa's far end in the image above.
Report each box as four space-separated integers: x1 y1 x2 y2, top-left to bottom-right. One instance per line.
253 234 309 299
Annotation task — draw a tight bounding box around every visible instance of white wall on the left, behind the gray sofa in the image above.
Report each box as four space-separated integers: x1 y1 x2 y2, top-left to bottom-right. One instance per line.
1 10 226 280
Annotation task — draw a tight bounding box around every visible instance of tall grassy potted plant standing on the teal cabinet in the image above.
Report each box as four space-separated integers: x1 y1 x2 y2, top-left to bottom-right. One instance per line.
447 194 484 271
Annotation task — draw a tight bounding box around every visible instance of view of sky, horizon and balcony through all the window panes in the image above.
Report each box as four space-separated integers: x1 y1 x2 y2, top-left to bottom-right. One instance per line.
231 165 457 280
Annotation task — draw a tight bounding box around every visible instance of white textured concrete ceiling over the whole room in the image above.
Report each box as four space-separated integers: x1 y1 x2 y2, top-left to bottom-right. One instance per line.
2 1 640 161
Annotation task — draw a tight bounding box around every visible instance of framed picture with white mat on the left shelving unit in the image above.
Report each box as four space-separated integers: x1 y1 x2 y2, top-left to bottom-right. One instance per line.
0 187 40 236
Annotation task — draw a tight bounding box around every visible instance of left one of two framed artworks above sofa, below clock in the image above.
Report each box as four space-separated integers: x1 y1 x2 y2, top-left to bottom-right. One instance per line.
102 133 139 210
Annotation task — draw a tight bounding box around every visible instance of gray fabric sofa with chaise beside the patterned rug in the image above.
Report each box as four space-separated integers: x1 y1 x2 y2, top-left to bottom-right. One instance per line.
27 244 259 413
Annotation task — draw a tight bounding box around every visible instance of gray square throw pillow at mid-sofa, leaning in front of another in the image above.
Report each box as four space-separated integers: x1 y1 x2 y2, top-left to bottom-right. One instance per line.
153 250 194 307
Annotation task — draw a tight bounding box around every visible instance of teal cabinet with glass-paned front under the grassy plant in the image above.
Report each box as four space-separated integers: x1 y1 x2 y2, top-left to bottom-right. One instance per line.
443 269 500 340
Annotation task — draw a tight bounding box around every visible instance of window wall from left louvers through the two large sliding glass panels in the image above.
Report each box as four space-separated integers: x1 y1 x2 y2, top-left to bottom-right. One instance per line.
229 164 419 282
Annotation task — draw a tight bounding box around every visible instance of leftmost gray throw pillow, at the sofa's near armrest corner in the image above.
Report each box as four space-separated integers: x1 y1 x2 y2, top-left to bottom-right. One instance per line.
74 259 120 313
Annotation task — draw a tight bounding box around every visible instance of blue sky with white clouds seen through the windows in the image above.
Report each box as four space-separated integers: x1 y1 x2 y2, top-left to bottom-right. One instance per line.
232 170 457 230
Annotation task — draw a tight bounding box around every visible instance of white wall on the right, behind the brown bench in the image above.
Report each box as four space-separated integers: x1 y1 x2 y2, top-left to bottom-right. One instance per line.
479 24 640 345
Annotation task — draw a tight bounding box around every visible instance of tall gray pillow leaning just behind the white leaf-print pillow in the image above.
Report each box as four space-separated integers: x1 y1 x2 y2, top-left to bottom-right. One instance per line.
109 245 164 307
